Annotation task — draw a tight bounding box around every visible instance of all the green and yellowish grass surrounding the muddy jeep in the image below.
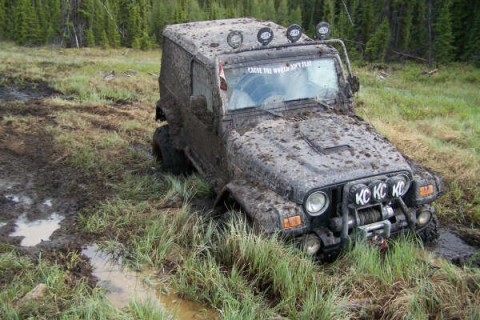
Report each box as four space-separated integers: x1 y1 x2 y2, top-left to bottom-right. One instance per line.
0 43 480 319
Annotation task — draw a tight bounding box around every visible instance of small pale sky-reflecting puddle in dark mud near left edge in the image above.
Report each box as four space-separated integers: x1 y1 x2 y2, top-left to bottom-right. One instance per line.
10 213 64 247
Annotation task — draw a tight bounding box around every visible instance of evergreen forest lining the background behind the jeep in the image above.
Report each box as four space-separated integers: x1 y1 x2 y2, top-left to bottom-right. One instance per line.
0 0 480 63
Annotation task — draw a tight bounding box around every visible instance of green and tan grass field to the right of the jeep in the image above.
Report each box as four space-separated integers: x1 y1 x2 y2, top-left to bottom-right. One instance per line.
356 65 480 226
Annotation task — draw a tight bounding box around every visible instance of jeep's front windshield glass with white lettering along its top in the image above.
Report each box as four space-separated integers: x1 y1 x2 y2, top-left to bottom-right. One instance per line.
225 58 338 111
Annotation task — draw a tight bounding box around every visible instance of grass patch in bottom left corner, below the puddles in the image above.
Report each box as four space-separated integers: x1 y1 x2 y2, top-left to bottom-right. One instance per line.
0 244 169 320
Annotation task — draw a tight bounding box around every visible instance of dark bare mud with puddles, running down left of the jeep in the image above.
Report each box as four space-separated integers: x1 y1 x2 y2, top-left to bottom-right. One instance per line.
0 81 218 319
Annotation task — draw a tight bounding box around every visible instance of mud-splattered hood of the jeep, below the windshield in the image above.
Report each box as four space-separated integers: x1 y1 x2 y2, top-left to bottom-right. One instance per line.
226 113 411 203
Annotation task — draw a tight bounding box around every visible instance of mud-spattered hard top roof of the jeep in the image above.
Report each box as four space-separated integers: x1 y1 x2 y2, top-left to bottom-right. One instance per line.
163 18 322 63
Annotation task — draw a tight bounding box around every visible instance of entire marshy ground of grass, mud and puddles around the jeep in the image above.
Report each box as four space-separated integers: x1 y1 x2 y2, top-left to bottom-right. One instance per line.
0 43 480 319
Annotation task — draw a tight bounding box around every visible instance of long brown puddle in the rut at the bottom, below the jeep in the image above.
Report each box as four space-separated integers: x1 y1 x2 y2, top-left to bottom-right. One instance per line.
82 245 218 320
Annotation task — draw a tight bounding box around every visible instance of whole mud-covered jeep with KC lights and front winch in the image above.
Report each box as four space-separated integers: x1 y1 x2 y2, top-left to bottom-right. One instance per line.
153 18 443 255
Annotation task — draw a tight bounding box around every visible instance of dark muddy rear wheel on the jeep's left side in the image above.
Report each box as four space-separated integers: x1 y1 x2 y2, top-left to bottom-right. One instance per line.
152 125 191 175
